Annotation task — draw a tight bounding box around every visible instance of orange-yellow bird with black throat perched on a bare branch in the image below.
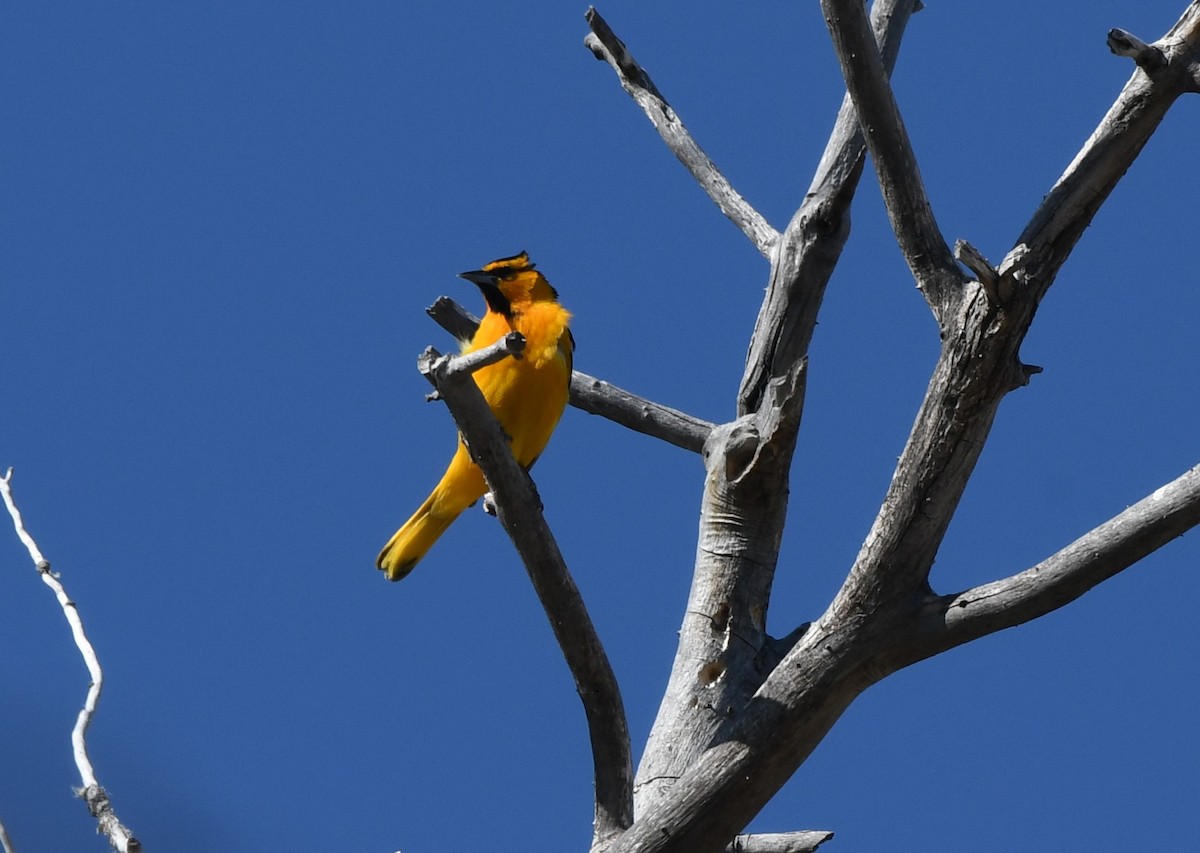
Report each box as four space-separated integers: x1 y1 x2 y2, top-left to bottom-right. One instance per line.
376 251 575 581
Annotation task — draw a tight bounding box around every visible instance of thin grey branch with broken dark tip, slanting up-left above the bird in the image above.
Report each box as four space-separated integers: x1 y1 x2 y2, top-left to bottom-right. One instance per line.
583 7 779 258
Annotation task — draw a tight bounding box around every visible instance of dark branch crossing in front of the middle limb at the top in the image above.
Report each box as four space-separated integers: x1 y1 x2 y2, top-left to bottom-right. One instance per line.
821 0 965 325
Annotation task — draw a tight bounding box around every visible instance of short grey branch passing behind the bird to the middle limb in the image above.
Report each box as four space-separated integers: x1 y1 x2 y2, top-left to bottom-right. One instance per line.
425 296 714 453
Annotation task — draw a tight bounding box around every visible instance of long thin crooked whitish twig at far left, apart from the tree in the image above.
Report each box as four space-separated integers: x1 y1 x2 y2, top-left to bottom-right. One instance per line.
0 468 142 853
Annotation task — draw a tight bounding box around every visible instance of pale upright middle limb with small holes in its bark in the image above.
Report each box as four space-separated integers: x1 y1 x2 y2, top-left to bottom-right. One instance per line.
630 0 913 825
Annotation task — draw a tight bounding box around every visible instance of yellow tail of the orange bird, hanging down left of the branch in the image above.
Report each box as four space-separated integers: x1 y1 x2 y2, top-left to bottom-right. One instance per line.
376 441 487 581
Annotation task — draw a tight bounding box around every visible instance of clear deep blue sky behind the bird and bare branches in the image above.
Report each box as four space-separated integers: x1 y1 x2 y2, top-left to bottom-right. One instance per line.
0 0 1200 853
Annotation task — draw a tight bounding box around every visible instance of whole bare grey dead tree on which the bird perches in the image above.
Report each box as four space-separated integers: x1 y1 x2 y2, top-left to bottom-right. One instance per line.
422 0 1200 853
